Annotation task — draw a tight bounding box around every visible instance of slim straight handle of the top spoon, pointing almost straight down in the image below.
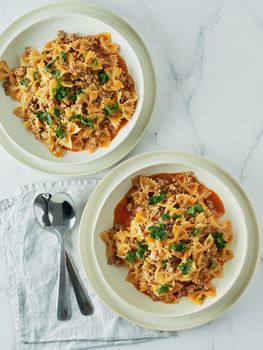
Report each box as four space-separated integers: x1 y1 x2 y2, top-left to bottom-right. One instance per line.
57 238 69 321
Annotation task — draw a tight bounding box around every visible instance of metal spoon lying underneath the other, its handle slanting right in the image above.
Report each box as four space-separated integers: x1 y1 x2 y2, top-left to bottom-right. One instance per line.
33 193 93 316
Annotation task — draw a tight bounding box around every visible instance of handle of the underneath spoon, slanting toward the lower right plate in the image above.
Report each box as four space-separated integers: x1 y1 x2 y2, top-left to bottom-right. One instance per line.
66 252 93 316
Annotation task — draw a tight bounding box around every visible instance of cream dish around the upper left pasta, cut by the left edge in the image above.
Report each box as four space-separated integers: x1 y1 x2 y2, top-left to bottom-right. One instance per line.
0 1 155 175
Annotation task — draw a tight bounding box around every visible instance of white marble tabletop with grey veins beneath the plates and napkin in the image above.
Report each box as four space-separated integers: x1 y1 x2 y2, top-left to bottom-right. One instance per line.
0 0 263 350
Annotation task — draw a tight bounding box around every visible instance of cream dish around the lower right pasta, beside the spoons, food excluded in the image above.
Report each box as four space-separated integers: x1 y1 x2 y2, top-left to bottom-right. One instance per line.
80 151 259 330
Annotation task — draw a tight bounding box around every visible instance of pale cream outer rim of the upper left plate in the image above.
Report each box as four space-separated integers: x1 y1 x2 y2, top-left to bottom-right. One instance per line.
0 1 156 176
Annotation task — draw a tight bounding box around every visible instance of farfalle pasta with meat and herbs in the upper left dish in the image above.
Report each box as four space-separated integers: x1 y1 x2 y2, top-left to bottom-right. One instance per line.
0 31 138 157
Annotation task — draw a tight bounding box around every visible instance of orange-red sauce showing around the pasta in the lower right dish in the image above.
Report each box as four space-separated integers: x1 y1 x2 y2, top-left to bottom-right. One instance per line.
114 173 225 227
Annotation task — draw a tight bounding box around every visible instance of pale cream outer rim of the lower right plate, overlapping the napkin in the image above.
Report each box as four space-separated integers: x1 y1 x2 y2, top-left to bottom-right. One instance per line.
79 151 259 331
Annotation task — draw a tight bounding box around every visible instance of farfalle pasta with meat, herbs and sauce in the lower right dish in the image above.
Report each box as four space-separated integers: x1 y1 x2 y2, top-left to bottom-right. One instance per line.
101 172 233 304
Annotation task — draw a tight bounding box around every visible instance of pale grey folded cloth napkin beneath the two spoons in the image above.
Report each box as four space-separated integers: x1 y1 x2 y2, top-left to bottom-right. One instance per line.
0 179 171 350
